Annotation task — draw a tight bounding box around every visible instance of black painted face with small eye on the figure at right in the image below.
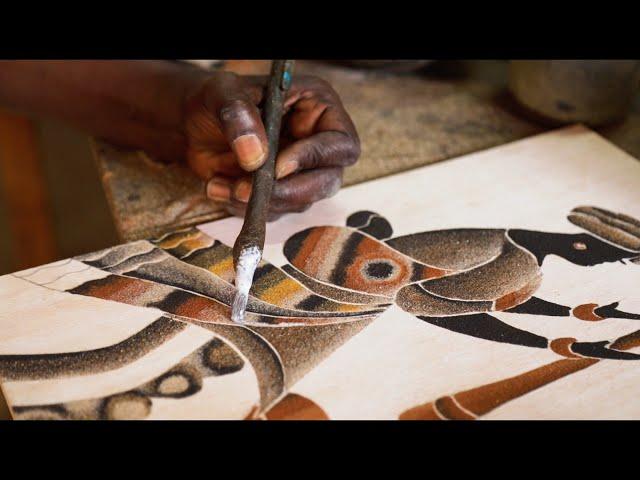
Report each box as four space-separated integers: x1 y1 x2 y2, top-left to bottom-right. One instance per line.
507 229 637 267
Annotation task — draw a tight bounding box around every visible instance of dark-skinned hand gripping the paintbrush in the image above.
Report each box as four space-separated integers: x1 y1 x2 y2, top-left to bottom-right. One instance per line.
185 72 360 220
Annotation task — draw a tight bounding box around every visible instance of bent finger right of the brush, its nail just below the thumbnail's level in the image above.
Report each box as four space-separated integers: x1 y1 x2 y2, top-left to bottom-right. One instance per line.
276 131 360 179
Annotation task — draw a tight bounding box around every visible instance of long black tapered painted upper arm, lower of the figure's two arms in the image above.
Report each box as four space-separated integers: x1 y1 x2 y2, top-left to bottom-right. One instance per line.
418 313 549 348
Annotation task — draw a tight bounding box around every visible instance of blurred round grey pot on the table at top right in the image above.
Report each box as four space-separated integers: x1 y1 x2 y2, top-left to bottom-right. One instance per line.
509 60 640 126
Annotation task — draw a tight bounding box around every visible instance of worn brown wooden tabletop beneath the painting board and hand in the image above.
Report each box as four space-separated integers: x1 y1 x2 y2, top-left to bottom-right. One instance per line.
94 61 640 241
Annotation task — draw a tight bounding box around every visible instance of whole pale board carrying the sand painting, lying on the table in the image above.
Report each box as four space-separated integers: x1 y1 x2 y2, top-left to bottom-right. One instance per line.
0 126 640 419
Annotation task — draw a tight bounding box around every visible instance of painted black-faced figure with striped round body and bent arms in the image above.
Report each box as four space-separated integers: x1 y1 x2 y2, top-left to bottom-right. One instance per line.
284 207 640 359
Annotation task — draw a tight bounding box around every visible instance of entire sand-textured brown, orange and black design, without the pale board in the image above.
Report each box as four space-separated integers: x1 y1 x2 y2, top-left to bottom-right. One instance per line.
0 203 640 419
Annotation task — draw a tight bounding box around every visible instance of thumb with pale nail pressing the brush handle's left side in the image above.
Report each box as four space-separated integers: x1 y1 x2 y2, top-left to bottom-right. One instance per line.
205 74 268 172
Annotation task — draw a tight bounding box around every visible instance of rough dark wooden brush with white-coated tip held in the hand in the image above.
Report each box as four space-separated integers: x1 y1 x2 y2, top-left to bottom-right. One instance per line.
231 60 293 322
